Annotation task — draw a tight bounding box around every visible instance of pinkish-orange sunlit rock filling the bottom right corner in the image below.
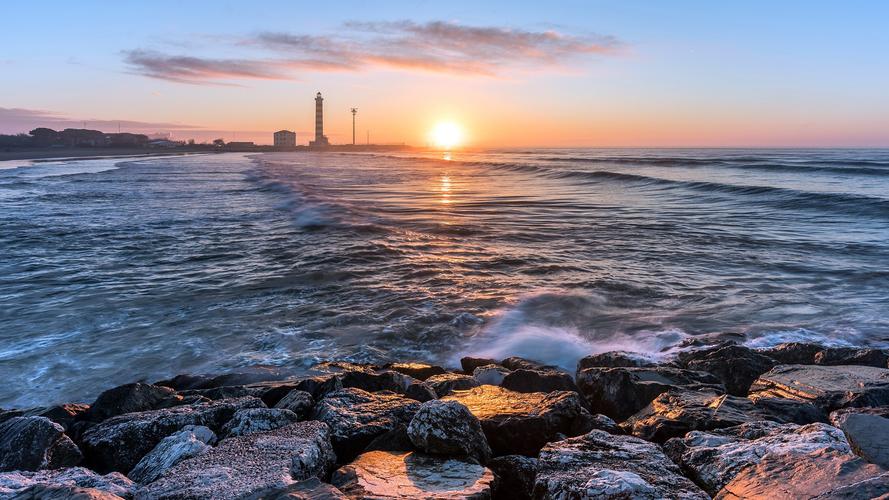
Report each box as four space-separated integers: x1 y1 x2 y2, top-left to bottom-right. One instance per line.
715 449 889 500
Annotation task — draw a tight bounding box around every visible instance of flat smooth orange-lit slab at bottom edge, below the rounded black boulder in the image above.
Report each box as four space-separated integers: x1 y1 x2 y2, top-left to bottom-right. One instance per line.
330 451 495 500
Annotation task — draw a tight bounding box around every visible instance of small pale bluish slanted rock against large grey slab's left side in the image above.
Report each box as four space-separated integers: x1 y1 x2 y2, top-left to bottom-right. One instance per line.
128 425 216 484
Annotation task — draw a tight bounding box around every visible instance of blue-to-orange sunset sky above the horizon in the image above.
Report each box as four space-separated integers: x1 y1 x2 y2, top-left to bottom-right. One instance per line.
0 0 889 148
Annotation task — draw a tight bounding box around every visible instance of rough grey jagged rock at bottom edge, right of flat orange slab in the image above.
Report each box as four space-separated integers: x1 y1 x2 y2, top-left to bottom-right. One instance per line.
533 430 710 500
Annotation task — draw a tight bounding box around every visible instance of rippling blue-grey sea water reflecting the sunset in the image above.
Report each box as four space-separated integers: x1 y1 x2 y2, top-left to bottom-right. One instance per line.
0 150 889 407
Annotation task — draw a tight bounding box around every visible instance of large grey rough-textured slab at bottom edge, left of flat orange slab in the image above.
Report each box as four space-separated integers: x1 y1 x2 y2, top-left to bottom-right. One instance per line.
135 422 336 500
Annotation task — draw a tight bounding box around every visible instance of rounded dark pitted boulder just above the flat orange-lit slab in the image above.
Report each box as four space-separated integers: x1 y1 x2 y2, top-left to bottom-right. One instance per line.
407 400 491 464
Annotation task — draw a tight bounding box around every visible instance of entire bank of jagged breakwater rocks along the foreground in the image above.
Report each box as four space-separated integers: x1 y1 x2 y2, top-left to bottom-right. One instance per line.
0 343 889 500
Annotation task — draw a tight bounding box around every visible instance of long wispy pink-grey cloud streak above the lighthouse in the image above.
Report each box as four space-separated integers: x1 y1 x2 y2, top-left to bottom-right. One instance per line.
125 21 623 83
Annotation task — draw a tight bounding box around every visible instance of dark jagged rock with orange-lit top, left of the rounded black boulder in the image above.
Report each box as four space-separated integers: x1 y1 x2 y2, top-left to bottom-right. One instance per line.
312 388 420 461
